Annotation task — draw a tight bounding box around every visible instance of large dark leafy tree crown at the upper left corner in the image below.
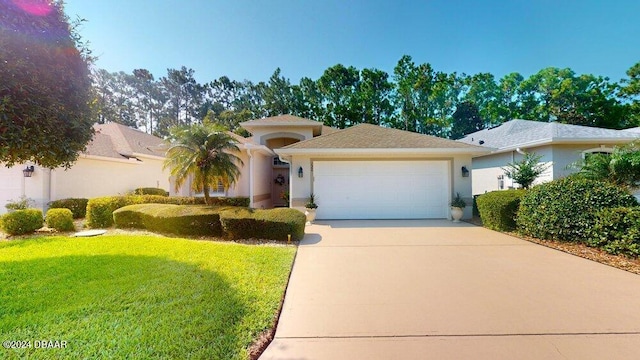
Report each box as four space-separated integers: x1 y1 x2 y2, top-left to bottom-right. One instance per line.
0 0 93 168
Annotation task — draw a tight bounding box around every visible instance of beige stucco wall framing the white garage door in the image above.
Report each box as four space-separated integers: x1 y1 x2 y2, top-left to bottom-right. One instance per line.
289 154 472 219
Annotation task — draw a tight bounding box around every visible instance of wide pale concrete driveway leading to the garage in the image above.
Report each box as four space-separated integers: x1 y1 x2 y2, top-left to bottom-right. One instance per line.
261 220 640 360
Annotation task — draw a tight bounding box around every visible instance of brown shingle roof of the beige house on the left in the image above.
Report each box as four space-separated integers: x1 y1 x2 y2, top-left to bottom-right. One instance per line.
84 123 164 159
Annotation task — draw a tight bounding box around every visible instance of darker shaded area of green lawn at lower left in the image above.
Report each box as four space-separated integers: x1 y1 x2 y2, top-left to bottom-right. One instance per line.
0 255 246 359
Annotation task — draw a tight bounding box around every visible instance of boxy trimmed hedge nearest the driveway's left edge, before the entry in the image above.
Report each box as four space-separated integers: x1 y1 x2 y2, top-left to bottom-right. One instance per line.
220 208 306 241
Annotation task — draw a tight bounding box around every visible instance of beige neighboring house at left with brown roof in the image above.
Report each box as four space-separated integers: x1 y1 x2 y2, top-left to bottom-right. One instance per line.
0 123 169 213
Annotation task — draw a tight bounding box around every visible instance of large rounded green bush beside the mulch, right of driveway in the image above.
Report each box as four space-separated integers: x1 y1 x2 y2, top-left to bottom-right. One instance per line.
517 176 638 242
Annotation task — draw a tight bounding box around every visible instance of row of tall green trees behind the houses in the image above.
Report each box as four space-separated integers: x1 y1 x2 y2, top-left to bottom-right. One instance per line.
92 55 640 139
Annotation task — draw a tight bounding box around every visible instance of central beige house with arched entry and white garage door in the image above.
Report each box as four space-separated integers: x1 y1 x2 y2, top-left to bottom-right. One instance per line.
178 115 489 219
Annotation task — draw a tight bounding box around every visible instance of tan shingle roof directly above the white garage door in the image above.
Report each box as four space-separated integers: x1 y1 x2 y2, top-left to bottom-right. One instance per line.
283 124 479 150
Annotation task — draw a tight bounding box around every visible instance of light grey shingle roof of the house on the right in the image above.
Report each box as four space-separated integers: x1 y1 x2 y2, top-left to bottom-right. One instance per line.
459 119 634 149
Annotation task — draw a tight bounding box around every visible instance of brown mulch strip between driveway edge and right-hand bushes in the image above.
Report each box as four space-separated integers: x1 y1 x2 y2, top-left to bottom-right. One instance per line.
469 218 640 275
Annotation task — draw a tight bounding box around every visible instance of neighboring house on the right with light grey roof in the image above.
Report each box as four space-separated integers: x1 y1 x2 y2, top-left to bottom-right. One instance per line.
459 119 640 195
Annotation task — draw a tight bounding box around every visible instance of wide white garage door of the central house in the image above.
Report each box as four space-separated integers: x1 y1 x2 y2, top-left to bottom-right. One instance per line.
313 161 450 219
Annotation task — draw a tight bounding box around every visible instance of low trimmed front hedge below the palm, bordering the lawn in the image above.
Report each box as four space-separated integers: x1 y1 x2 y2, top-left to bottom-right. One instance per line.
113 204 228 236
